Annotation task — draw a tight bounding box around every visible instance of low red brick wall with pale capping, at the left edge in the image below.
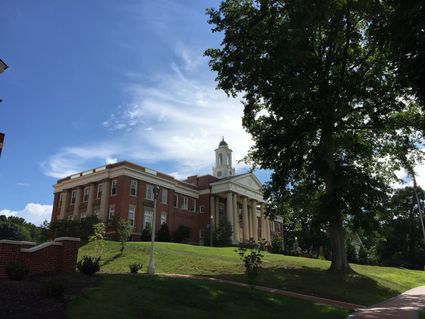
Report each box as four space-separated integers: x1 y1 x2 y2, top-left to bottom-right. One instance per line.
0 237 80 278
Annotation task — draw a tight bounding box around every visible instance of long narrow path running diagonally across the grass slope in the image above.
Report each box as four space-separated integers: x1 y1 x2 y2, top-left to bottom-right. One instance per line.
161 274 364 310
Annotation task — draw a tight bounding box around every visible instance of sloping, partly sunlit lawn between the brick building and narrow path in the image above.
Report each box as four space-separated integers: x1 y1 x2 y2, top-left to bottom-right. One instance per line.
79 242 425 305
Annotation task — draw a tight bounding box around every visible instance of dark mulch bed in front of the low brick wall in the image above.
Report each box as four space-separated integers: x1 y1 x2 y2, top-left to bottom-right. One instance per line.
0 273 98 319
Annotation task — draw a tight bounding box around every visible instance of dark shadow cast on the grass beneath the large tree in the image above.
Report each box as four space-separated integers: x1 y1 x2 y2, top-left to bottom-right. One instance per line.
207 267 399 306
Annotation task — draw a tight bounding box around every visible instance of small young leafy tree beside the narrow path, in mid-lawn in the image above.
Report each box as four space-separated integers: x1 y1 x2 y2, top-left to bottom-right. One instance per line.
236 241 264 284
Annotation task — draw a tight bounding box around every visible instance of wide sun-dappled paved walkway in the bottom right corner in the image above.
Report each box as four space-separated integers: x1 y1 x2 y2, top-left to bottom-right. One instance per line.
348 286 425 319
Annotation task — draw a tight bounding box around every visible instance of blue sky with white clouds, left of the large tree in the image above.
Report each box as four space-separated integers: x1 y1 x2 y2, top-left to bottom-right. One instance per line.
0 0 267 224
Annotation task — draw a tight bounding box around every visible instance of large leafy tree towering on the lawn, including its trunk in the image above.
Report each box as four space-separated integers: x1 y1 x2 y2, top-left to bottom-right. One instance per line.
205 0 425 272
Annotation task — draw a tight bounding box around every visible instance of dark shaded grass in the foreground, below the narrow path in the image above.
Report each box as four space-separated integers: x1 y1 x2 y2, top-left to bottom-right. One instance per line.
67 274 349 319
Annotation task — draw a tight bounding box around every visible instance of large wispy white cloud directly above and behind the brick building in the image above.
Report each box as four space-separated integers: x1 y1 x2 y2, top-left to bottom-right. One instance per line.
42 46 252 178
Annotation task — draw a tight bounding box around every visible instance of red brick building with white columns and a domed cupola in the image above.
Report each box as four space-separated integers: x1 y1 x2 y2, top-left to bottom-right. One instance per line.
52 139 282 243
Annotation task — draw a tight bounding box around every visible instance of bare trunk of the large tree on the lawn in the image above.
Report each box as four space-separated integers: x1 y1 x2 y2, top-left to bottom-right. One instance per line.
329 215 351 272
